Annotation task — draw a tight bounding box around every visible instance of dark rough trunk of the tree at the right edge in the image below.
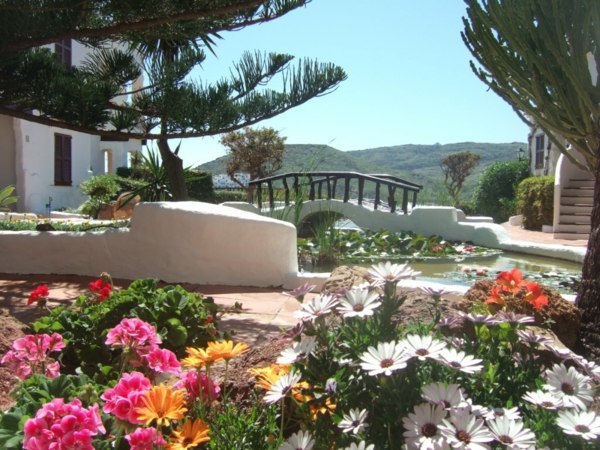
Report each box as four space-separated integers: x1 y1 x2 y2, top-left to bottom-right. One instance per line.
576 159 600 360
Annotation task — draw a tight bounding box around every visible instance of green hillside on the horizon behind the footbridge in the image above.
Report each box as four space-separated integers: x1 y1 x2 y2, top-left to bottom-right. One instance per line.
198 142 527 204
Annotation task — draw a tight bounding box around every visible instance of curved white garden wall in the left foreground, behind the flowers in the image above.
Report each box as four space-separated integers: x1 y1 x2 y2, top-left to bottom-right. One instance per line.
0 202 298 286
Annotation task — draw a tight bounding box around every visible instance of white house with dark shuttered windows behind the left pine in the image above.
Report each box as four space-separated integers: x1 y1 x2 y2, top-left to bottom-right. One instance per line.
0 39 142 214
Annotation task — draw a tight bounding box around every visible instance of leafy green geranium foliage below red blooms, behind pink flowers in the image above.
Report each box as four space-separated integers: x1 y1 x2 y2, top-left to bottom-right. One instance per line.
32 279 216 374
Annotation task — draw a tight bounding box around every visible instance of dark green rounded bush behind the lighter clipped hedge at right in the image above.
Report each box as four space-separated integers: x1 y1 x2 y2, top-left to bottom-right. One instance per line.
474 161 529 223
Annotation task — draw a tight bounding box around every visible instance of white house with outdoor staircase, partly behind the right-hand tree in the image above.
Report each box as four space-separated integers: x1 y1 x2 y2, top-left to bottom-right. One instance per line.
529 126 594 240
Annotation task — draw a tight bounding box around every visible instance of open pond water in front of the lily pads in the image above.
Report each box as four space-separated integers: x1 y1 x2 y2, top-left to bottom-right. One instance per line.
303 252 581 294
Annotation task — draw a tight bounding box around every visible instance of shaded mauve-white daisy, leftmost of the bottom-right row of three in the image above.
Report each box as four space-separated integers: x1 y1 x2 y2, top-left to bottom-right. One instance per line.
402 403 446 448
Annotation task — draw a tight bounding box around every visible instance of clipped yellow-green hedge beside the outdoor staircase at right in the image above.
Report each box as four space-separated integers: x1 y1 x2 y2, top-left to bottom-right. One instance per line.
517 177 554 231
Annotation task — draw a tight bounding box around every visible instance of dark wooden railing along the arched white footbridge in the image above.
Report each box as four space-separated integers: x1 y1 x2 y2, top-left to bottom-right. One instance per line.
249 172 423 214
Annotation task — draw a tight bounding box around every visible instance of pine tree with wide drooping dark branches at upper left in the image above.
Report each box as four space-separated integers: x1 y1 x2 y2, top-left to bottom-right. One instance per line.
0 0 346 200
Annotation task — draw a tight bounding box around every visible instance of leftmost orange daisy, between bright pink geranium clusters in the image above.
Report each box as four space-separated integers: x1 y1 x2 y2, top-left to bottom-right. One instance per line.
135 384 187 427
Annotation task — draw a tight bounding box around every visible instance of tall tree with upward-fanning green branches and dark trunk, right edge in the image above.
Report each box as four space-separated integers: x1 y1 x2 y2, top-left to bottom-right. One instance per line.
462 0 600 356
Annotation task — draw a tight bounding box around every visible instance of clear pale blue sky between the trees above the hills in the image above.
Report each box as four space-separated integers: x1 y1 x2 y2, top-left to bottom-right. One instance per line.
172 0 527 166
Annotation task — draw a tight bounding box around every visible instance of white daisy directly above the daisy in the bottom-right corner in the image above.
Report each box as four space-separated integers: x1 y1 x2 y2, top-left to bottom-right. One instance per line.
544 364 594 410
